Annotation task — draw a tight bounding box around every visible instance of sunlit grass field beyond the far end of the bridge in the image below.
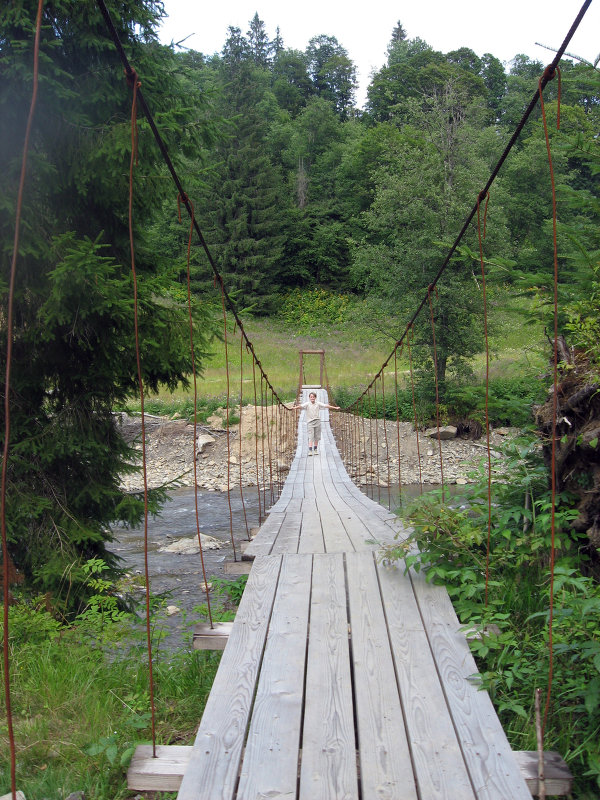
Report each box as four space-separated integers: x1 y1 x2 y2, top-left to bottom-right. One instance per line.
123 297 547 413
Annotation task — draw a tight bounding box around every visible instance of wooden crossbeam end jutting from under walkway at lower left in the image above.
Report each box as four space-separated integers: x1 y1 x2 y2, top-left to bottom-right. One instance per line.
127 744 192 792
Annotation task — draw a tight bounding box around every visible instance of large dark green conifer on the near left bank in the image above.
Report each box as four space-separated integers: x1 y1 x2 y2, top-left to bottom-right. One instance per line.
0 0 216 603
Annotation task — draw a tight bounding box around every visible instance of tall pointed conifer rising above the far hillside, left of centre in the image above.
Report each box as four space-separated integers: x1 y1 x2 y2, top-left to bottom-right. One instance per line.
192 49 289 314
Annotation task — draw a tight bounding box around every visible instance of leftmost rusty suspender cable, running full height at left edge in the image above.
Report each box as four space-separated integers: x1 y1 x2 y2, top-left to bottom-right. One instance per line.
0 0 44 800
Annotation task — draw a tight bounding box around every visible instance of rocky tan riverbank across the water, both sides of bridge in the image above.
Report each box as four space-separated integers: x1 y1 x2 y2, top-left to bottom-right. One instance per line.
119 406 512 492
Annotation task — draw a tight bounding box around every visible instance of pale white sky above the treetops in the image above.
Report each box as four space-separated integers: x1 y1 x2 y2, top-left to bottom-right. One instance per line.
160 0 600 106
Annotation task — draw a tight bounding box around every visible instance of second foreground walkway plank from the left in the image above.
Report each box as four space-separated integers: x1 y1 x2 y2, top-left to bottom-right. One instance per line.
237 555 312 800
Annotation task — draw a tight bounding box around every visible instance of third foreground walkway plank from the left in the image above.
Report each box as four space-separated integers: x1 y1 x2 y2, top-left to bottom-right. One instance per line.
299 553 358 800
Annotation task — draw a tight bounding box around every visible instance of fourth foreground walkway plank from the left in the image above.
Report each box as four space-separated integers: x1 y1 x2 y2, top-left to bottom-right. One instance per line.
346 553 417 800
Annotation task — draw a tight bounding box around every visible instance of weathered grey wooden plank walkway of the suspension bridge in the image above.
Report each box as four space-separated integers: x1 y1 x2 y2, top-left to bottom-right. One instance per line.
178 390 531 800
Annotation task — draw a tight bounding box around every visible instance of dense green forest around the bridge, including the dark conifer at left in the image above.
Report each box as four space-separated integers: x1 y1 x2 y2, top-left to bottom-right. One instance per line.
0 0 600 797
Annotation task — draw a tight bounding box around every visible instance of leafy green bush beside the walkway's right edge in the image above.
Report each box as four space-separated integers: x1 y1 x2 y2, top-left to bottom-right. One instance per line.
386 437 600 800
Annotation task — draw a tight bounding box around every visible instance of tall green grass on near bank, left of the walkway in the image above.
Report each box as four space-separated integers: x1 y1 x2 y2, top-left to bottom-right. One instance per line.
0 604 219 800
